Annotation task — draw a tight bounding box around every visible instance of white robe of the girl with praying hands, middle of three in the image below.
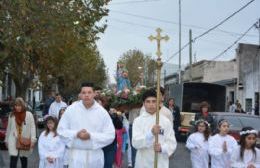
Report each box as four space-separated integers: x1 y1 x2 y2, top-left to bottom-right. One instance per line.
209 134 237 168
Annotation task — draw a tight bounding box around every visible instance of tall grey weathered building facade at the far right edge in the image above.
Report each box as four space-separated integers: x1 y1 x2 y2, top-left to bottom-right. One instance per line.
236 43 260 112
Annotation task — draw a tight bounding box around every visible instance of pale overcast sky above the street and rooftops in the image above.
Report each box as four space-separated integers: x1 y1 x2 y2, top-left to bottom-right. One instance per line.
97 0 260 82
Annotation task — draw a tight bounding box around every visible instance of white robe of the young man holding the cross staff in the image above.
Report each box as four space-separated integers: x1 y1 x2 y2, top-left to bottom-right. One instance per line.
132 111 177 168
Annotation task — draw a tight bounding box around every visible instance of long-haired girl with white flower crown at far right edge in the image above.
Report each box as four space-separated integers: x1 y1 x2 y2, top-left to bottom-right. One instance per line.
231 127 260 168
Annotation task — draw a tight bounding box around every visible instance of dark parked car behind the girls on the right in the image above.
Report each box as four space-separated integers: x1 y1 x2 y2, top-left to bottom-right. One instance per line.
211 112 260 148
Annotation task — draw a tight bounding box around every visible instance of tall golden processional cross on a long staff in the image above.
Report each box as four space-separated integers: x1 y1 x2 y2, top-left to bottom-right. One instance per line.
149 28 169 168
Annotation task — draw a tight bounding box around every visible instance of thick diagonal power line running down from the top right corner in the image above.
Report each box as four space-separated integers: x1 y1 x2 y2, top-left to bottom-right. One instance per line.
167 0 255 62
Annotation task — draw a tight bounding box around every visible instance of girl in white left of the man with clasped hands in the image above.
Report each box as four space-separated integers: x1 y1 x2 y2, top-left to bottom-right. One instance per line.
38 116 65 168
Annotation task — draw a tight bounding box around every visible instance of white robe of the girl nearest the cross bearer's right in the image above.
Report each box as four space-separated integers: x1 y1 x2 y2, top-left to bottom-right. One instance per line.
186 132 209 168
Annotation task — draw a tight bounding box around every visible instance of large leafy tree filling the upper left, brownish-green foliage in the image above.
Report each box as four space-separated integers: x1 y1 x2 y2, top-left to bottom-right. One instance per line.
0 0 108 96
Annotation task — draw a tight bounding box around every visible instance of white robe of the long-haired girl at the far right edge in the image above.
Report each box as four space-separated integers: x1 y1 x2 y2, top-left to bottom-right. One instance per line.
231 146 260 168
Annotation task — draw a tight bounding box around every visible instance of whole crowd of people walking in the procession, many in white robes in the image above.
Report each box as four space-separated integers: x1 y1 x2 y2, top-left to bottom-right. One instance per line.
0 82 260 168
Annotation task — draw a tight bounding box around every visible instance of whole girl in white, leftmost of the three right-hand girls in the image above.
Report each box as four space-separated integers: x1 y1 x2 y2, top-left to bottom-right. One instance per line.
186 120 210 168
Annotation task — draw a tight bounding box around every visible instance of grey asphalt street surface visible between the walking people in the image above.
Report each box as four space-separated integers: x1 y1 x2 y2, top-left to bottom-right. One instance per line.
0 142 191 168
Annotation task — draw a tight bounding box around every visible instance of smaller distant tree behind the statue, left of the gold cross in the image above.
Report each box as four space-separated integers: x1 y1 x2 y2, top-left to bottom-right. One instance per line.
119 49 156 87
